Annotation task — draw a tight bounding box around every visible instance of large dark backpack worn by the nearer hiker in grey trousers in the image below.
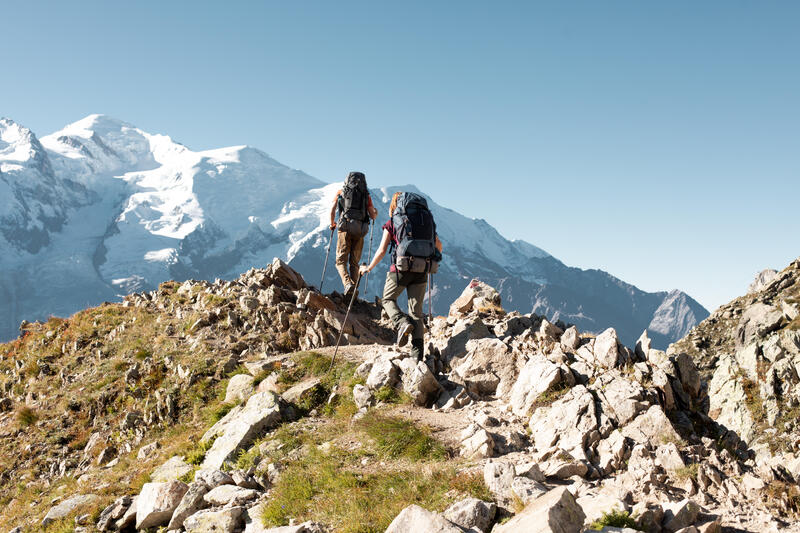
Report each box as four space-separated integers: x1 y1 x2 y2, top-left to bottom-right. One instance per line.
392 192 441 273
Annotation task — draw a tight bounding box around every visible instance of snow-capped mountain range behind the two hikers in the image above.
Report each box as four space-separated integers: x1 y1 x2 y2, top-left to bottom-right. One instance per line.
0 115 708 346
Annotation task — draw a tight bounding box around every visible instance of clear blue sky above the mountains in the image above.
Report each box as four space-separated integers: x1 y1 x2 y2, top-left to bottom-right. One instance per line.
0 0 800 309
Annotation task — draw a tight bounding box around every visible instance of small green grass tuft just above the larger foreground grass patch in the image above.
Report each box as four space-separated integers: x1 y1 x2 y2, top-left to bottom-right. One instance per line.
358 411 447 461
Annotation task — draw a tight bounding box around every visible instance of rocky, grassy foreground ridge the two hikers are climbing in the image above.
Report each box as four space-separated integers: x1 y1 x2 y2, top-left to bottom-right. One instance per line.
0 260 800 533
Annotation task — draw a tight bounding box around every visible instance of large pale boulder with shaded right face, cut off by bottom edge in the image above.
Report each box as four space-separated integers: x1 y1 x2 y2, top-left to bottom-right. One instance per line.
492 487 586 533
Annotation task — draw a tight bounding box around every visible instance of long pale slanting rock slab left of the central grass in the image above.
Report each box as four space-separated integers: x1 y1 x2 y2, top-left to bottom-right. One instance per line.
202 392 281 469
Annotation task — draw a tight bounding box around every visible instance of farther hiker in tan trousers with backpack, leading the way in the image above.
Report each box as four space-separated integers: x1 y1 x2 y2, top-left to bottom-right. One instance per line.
330 172 378 296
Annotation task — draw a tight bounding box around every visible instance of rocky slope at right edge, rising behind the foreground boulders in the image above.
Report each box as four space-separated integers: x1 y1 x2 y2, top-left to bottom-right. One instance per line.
670 259 800 476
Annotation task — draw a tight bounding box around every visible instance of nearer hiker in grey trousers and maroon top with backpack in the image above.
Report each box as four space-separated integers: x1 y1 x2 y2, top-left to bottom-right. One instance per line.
360 192 442 361
